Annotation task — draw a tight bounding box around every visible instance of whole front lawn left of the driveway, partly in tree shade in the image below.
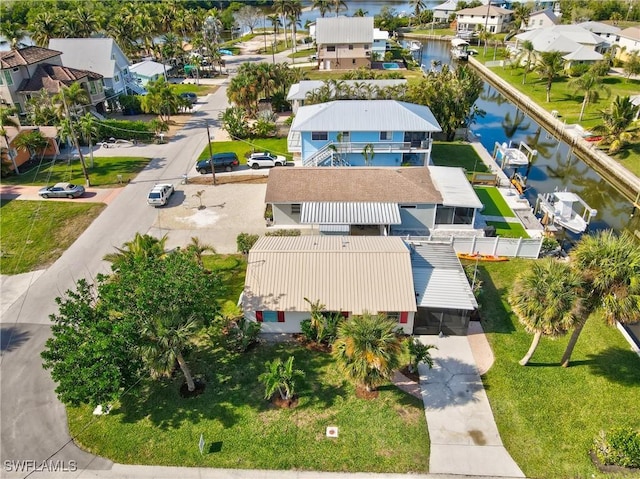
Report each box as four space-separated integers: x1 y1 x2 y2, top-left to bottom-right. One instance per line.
68 341 429 473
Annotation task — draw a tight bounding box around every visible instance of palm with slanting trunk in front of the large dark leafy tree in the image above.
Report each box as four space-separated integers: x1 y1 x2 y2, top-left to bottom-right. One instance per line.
140 312 201 391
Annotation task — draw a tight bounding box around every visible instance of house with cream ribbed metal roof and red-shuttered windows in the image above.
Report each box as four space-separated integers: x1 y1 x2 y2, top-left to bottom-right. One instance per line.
241 236 417 333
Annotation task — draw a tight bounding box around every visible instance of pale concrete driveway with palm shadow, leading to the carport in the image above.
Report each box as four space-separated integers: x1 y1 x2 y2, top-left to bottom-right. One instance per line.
419 336 525 477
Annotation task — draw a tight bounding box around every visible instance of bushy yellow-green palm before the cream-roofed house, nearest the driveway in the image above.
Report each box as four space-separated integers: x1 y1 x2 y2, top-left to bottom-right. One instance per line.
333 313 402 391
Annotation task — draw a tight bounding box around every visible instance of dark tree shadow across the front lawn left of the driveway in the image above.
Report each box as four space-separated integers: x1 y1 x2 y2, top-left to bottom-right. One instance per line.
111 343 346 430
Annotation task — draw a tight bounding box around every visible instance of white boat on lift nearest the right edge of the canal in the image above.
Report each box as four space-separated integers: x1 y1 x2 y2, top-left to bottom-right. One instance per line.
535 191 598 234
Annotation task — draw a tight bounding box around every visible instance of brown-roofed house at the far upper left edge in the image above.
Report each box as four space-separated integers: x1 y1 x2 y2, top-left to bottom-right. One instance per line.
0 46 105 114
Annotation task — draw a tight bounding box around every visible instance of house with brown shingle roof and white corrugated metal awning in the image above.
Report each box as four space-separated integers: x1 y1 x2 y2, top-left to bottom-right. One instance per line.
265 166 484 237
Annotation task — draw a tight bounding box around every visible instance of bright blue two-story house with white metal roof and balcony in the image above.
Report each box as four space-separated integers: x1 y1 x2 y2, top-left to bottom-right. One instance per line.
288 100 442 167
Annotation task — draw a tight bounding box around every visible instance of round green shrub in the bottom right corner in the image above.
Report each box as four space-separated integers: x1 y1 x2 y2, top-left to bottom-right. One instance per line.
594 427 640 467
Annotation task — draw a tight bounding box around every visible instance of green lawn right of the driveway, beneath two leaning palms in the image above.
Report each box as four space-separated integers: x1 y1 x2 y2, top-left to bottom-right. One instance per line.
480 260 640 479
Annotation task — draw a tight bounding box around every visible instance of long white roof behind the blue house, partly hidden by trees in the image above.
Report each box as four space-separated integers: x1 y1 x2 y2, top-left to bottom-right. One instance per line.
287 78 407 115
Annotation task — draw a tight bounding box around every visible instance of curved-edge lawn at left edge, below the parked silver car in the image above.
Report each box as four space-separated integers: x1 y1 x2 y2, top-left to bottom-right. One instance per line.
0 200 105 274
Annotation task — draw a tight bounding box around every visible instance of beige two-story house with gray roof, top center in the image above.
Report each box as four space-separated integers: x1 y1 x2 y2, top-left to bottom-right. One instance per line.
316 17 374 70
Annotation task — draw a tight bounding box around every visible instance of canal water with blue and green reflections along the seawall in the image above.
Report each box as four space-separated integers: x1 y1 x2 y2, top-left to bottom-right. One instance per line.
414 41 640 233
